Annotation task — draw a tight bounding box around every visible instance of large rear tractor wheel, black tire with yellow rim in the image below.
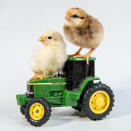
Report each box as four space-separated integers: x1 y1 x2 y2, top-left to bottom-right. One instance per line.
81 83 114 120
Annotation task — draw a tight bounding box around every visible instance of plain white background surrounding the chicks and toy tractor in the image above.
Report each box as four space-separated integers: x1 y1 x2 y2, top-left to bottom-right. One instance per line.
0 0 131 131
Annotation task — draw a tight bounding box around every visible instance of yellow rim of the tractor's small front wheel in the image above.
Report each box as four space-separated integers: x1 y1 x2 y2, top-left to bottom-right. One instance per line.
29 103 45 120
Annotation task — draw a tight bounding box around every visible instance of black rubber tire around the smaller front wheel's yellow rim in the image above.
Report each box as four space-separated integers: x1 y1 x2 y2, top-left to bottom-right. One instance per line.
25 98 51 127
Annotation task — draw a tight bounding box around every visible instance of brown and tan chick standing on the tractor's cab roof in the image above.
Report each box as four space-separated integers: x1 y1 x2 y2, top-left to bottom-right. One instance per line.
63 8 104 63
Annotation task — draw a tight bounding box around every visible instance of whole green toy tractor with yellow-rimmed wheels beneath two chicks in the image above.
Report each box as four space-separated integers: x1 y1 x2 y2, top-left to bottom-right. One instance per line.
16 57 114 126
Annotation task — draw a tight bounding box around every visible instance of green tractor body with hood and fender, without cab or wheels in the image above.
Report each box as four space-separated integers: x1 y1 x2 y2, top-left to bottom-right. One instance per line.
16 77 99 107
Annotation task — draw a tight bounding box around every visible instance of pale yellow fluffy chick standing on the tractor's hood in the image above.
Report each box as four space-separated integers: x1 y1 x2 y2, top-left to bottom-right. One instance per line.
29 31 67 80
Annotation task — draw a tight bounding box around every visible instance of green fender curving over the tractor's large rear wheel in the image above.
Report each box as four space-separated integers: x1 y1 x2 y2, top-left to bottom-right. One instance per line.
79 77 100 94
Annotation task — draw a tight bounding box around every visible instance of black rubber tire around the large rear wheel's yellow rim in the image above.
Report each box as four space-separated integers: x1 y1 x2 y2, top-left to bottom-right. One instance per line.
81 83 114 120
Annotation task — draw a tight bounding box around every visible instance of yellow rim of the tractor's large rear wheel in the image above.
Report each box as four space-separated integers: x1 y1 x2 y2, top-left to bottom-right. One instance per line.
89 91 110 114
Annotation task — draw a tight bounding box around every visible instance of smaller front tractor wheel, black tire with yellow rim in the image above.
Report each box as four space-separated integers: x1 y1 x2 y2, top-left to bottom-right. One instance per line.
25 98 51 126
